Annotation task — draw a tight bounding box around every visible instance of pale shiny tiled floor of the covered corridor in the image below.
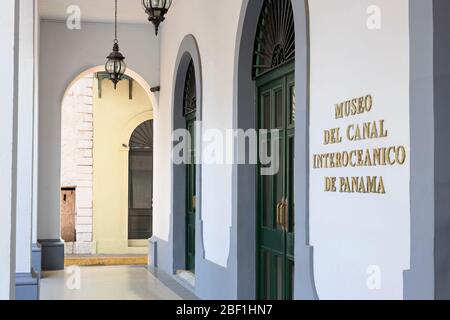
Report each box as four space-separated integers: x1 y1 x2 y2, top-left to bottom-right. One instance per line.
40 266 195 300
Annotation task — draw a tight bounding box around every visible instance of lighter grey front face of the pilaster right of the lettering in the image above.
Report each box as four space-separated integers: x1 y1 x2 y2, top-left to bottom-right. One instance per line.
404 0 435 300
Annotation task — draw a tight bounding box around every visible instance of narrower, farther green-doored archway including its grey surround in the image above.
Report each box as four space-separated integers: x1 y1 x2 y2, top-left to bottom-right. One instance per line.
170 35 203 284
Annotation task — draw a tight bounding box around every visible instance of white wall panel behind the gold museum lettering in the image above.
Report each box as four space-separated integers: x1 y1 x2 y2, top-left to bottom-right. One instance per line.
310 0 410 299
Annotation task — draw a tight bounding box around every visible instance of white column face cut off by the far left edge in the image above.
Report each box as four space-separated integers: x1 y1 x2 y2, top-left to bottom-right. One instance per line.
0 0 19 299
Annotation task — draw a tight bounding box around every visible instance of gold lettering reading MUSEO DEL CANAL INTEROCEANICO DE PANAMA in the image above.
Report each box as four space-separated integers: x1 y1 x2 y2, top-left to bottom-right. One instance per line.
312 94 407 195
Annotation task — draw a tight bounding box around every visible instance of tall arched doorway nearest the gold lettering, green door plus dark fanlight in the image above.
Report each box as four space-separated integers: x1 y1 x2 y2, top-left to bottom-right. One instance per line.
253 0 296 300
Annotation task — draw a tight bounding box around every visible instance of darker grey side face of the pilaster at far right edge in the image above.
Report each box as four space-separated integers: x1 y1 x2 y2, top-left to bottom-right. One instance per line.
430 0 450 299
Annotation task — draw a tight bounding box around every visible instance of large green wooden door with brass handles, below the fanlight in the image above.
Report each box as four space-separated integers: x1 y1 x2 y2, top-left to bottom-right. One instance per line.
257 63 295 300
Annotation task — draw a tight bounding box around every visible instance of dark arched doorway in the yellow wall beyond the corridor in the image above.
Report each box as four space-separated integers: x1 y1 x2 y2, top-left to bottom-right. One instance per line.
128 120 153 240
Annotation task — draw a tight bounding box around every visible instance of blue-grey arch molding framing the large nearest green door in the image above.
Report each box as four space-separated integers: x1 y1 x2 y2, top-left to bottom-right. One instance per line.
230 0 317 299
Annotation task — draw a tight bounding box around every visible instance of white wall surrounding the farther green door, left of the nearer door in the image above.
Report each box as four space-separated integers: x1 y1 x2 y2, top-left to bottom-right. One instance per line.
154 0 242 266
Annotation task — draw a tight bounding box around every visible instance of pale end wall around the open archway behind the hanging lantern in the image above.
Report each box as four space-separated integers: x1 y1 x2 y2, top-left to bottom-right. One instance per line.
38 21 159 239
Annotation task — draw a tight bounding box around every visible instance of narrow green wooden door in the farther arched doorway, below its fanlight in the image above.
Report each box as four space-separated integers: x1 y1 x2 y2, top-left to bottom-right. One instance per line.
186 113 196 273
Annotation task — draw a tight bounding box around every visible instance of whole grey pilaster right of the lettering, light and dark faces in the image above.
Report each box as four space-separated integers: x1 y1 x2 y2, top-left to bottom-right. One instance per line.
405 0 450 299
